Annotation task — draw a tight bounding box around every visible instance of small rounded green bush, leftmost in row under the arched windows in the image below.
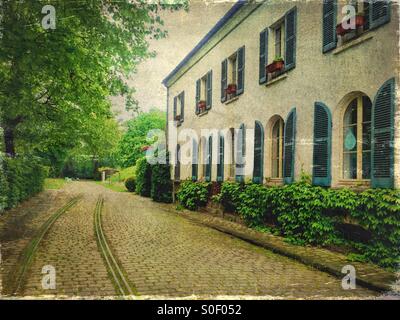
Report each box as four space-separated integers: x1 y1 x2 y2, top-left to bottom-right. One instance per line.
176 180 211 210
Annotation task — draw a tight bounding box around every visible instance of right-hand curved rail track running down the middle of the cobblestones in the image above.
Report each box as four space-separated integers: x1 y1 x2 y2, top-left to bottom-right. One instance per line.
94 197 137 297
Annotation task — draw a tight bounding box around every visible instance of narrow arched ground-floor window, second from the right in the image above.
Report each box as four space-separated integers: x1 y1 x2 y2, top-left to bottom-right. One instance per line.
271 117 284 178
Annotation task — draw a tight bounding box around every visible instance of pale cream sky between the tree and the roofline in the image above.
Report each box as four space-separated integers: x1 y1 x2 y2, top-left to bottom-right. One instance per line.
111 0 235 121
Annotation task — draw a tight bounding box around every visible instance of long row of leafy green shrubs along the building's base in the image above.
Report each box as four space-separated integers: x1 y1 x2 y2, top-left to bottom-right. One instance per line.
178 177 400 268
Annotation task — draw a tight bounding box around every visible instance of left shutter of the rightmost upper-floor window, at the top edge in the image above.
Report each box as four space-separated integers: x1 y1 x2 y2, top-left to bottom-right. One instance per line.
322 0 337 53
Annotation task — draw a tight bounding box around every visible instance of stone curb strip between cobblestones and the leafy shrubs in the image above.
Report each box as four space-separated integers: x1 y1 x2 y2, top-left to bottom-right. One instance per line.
159 208 397 293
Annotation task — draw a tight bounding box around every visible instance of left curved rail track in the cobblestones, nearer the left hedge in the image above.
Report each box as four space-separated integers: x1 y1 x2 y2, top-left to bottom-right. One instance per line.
12 195 81 295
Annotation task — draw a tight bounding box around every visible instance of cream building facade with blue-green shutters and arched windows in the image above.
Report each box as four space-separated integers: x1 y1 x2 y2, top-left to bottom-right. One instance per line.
164 0 400 188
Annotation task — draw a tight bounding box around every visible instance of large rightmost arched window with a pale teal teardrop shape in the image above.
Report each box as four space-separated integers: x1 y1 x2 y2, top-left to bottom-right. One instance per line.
343 95 372 180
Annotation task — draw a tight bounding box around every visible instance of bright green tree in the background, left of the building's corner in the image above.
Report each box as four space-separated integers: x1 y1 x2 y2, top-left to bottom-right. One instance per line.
117 110 166 168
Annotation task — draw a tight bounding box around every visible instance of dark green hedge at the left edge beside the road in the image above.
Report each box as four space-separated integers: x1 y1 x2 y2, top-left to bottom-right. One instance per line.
0 156 48 211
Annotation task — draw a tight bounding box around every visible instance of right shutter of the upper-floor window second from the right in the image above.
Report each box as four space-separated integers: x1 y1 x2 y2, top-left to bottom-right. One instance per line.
285 7 297 70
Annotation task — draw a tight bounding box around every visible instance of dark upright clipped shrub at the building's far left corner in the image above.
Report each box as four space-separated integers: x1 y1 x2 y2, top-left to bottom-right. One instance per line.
151 157 172 203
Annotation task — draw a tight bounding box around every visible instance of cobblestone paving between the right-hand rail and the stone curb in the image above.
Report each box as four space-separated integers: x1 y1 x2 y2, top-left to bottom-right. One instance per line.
103 188 375 298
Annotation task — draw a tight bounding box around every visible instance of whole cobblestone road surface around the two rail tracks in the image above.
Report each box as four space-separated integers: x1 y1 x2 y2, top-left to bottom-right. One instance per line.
0 182 377 299
